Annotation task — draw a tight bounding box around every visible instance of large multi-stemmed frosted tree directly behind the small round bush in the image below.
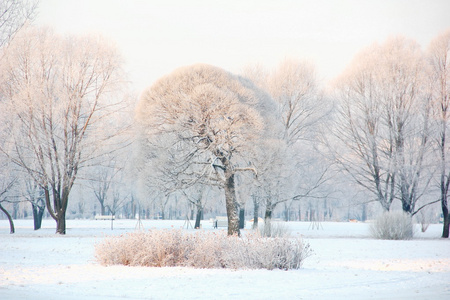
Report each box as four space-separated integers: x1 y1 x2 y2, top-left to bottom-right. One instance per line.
331 38 431 214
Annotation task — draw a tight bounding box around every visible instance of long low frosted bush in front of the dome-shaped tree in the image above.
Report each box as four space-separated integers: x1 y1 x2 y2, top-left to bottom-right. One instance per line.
95 230 311 270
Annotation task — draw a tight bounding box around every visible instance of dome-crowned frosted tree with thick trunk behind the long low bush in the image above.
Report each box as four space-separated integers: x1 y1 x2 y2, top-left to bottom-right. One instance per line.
136 64 273 235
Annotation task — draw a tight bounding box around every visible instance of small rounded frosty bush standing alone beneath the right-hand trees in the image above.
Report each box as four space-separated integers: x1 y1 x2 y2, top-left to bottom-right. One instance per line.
370 211 414 240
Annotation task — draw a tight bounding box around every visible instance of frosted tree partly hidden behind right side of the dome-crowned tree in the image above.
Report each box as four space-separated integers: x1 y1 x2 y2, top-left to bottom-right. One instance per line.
244 59 329 231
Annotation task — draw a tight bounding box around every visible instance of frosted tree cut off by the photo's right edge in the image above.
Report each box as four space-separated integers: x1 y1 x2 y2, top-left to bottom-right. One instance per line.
428 30 450 238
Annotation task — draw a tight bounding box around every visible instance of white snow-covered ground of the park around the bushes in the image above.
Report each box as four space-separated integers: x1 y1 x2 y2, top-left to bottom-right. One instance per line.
0 220 450 299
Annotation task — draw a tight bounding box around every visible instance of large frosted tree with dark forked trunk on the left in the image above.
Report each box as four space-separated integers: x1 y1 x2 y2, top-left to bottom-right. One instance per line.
0 28 122 234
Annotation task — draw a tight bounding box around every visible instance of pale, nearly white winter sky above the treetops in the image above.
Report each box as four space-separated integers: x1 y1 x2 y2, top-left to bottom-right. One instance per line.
36 0 450 92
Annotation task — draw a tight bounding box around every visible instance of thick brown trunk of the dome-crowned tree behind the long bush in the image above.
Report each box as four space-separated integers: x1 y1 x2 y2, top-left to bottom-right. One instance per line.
224 167 241 236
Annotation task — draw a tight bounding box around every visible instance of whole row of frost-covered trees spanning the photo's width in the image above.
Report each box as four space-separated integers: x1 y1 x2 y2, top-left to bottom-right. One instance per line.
0 1 450 237
